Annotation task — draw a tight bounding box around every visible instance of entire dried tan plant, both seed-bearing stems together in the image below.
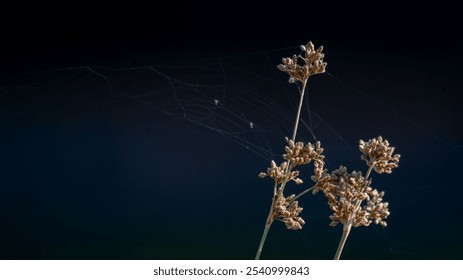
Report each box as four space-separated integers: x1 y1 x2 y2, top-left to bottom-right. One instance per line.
255 42 400 260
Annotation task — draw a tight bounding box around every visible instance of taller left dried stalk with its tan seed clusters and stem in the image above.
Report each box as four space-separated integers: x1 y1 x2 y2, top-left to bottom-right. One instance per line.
256 42 326 260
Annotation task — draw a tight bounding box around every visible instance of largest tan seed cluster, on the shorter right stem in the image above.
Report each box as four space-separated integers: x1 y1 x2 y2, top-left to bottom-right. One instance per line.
316 166 390 227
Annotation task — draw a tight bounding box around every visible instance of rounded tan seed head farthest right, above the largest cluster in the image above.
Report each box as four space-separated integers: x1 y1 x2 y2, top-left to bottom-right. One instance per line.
359 136 400 174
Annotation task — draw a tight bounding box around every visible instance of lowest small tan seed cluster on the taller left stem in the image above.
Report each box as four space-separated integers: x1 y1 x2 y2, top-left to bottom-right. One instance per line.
273 194 305 230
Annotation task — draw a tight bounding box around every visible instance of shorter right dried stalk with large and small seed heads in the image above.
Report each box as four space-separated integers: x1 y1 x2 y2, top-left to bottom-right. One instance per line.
313 136 400 260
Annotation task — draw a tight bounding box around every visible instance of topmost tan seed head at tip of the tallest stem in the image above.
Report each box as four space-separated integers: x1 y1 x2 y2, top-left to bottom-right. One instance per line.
278 42 326 83
